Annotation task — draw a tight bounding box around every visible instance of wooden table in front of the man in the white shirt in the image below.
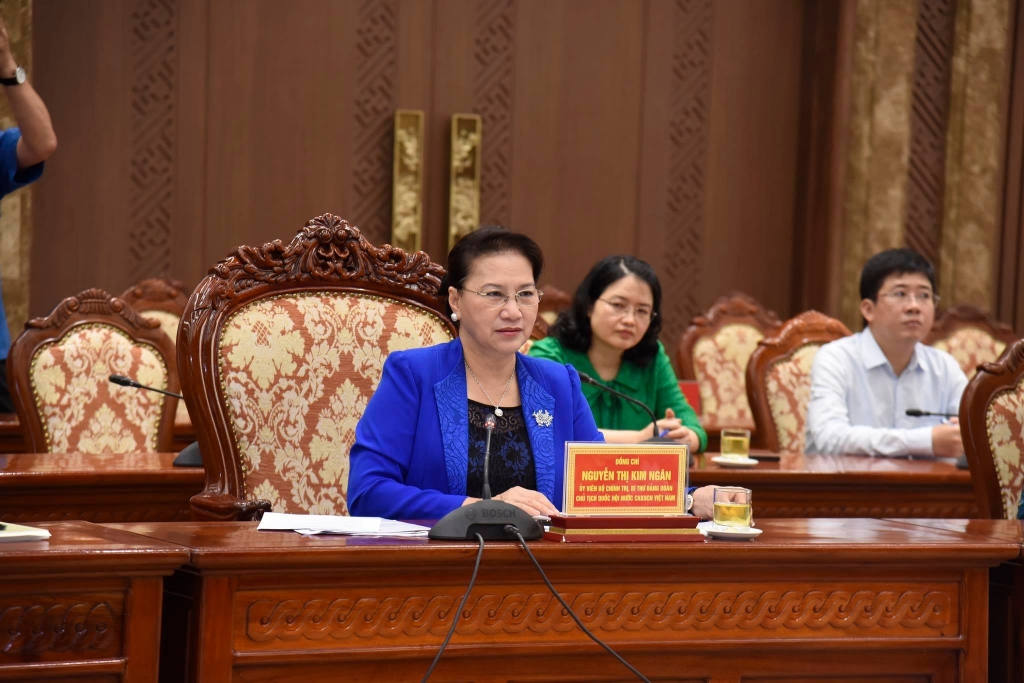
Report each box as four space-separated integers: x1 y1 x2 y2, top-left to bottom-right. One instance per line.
690 452 978 519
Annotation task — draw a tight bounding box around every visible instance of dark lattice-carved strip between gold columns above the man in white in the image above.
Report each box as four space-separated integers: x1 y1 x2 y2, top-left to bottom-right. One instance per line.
903 0 956 264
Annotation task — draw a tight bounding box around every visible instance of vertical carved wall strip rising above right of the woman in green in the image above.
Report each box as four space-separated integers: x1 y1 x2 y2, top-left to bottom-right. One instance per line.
660 0 714 348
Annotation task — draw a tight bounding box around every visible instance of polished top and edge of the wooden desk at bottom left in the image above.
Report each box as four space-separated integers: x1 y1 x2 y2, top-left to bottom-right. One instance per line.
0 521 190 575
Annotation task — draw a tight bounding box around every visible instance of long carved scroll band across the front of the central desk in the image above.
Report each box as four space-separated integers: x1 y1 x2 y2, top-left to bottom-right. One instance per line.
246 589 956 642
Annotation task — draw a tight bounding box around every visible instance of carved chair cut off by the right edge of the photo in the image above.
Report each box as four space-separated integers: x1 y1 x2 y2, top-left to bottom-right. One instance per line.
959 340 1024 519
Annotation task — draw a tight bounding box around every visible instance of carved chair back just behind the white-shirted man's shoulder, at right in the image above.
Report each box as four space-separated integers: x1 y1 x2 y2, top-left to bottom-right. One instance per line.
925 305 1018 378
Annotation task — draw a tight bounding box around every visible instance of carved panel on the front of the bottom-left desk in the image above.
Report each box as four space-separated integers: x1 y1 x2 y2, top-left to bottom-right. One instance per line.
0 595 124 661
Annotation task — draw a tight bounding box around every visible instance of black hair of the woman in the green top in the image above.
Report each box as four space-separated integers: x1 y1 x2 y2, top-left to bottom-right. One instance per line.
550 255 662 367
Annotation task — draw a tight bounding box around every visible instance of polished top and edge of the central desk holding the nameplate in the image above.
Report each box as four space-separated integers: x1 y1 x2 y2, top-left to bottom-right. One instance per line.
106 519 1021 571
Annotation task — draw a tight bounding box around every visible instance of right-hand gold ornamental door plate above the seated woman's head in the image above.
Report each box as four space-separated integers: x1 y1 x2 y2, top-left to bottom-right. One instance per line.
449 114 483 249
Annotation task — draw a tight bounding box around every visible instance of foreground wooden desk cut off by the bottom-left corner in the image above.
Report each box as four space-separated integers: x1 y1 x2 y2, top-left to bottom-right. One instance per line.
0 522 188 683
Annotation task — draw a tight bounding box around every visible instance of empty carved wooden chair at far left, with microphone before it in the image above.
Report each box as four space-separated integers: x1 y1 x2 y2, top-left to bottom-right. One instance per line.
7 289 178 453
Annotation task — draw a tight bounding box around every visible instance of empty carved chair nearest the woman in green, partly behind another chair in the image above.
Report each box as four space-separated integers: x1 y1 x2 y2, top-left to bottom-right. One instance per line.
677 292 782 427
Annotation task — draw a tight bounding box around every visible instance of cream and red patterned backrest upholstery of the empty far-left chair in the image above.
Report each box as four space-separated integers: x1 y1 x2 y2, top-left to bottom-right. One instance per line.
30 324 168 453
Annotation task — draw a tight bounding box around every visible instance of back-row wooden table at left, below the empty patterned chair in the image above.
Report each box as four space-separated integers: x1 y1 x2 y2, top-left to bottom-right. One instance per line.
0 453 206 522
